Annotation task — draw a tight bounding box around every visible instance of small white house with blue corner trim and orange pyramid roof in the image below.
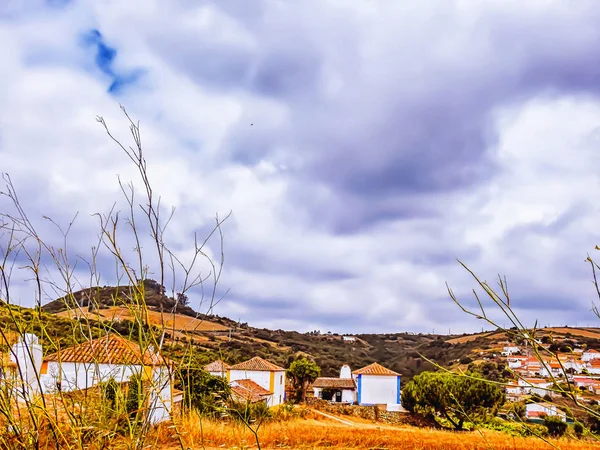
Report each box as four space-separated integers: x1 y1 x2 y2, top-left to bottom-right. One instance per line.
352 363 401 411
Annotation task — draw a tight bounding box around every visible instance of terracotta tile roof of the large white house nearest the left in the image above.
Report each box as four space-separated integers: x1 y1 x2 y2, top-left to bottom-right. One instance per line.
44 334 171 366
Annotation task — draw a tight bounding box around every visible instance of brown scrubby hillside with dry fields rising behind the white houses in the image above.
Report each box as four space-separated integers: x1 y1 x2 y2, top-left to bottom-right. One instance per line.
43 280 600 380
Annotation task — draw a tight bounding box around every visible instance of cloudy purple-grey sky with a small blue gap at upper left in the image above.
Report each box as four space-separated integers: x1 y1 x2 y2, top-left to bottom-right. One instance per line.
0 0 600 333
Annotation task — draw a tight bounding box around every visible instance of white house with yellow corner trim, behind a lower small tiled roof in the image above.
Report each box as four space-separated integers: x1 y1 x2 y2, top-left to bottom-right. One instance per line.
227 356 285 406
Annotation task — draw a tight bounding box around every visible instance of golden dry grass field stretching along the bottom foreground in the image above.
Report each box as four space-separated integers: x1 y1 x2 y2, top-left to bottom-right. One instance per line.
144 416 600 450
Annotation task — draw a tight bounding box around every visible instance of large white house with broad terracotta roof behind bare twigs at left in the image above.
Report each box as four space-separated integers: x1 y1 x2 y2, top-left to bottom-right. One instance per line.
39 334 181 424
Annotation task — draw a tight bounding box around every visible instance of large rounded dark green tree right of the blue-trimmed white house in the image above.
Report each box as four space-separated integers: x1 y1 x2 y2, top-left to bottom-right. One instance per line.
402 372 505 430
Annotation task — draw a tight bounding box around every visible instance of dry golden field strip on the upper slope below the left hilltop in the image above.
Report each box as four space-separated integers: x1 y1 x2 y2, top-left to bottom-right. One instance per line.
56 306 228 331
